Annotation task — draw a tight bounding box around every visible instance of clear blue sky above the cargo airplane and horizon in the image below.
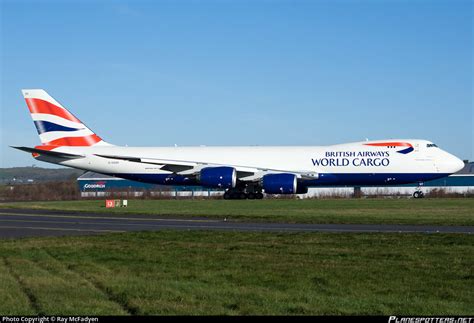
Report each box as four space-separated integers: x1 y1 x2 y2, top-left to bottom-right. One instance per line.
0 0 474 167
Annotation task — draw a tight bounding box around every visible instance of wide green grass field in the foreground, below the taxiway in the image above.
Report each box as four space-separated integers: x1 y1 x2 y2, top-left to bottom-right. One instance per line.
0 231 474 316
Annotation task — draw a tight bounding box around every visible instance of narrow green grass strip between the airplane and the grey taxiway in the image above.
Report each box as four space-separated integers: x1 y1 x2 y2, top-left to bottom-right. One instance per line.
0 198 474 225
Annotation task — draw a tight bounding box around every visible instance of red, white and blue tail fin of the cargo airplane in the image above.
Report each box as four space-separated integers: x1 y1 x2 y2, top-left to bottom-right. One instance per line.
22 90 107 150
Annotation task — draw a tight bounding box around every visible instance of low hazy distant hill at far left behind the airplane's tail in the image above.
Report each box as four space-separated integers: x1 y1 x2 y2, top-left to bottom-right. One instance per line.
0 167 84 184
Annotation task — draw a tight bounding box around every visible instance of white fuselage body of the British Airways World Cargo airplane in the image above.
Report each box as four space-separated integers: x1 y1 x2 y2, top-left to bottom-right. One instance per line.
40 139 463 185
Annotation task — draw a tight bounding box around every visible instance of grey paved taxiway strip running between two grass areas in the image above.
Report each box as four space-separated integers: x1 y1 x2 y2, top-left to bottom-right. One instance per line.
0 209 474 238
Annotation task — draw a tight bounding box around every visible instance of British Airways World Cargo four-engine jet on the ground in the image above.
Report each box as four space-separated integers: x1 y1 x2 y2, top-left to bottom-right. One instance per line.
12 89 464 199
